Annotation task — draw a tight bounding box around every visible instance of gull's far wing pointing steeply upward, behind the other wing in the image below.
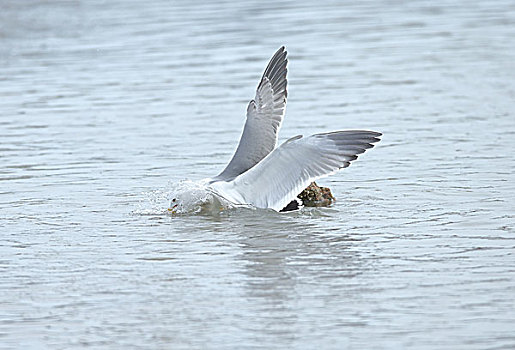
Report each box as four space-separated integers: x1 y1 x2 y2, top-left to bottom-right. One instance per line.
213 46 288 181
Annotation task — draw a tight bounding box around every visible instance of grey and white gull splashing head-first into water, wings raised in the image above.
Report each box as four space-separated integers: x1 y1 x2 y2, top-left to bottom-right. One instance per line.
169 46 381 212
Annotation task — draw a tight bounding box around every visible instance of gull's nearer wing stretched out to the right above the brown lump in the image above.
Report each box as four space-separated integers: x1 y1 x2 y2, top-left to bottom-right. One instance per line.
220 130 381 211
